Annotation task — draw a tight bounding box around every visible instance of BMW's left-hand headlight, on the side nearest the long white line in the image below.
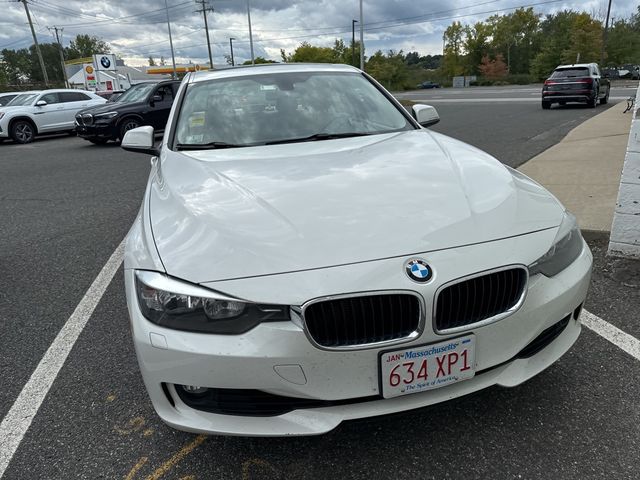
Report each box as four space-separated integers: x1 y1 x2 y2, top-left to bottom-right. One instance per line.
136 271 290 334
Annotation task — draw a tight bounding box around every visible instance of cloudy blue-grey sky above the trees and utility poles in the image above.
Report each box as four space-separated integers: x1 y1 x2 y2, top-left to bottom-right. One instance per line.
0 0 640 66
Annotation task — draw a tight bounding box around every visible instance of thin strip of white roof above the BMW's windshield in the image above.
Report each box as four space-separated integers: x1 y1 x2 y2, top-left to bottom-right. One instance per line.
189 63 360 83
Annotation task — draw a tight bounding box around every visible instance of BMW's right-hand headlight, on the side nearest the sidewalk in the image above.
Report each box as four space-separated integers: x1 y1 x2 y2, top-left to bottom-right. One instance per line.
529 212 582 277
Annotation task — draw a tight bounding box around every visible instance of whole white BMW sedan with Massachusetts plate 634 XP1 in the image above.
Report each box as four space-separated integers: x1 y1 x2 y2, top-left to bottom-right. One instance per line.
122 64 592 436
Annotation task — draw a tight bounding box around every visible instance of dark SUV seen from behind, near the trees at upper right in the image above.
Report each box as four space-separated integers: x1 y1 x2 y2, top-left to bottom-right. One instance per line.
542 63 611 110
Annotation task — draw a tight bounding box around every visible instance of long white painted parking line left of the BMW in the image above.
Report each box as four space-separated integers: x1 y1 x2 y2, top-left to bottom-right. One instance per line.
0 240 124 478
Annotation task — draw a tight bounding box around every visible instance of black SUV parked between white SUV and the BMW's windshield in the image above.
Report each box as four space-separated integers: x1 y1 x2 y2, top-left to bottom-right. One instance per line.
75 80 180 144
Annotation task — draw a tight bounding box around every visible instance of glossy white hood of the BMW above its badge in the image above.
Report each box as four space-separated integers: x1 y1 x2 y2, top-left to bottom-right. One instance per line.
149 130 563 283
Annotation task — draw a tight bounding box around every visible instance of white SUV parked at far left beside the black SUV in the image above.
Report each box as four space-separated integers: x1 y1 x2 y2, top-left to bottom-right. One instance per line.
0 89 106 143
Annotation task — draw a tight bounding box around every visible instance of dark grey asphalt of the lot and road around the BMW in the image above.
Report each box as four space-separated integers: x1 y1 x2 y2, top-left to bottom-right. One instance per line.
0 88 640 480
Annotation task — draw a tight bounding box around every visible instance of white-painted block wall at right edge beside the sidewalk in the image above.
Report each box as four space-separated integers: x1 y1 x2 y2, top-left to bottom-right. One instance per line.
608 86 640 258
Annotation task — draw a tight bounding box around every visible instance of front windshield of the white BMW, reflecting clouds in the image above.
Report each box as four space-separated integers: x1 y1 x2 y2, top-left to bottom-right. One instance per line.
176 72 415 149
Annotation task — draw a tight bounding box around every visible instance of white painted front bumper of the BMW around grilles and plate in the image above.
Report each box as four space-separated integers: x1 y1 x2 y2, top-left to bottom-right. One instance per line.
125 230 592 436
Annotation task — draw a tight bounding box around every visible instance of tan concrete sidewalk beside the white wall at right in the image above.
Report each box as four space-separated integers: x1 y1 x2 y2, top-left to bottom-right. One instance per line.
518 102 632 233
